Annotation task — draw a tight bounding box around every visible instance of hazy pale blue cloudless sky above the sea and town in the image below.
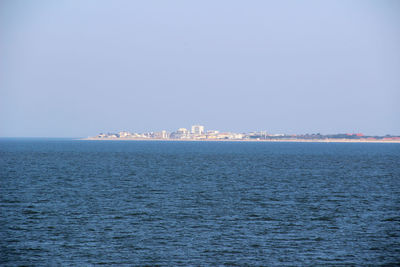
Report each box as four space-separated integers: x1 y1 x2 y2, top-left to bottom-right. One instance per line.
0 0 400 137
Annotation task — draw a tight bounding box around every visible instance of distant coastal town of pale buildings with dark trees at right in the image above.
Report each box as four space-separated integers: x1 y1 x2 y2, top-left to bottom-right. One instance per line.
89 125 400 141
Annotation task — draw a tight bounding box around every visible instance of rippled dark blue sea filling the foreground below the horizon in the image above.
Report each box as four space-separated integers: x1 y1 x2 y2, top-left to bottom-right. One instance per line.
0 139 400 266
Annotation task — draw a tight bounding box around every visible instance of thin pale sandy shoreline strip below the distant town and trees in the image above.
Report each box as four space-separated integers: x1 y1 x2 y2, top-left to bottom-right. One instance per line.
79 137 400 144
